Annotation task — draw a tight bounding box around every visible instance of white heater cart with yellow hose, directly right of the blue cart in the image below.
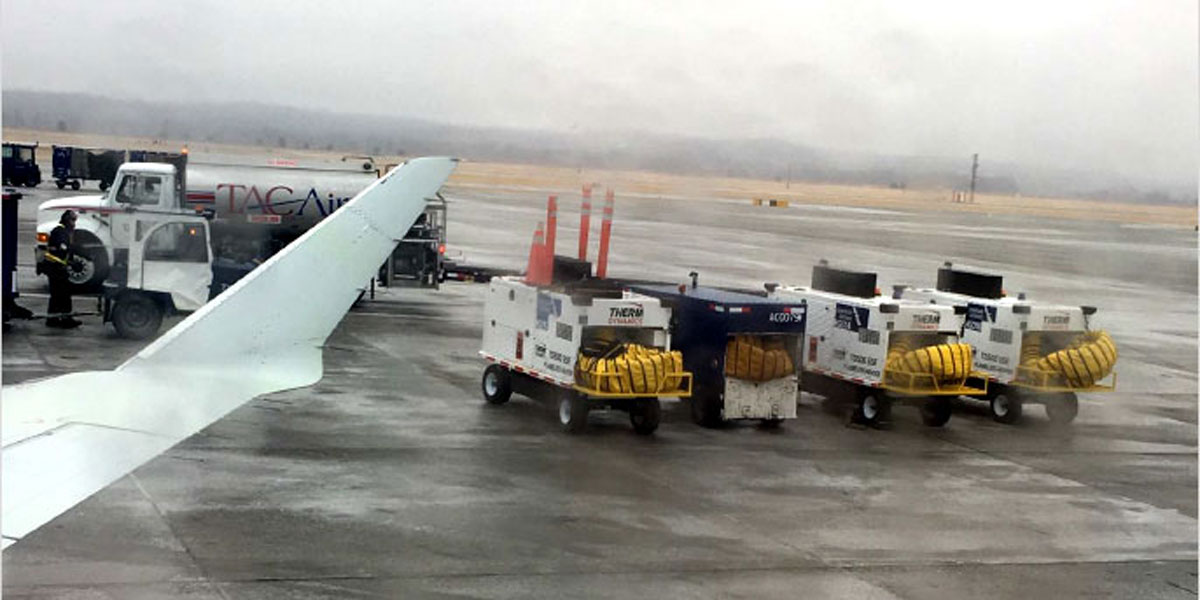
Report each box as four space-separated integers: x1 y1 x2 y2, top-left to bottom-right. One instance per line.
767 260 986 427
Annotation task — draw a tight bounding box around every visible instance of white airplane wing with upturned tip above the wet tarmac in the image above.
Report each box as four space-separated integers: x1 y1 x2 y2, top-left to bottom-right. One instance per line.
0 157 457 547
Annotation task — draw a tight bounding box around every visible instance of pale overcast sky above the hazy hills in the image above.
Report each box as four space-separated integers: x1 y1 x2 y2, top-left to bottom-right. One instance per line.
0 0 1200 184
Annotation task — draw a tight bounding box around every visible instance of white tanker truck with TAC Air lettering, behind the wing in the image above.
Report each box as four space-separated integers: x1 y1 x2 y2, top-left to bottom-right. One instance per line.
35 152 445 290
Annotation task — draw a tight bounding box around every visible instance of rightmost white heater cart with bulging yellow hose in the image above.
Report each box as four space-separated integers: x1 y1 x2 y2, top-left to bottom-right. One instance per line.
896 263 1117 424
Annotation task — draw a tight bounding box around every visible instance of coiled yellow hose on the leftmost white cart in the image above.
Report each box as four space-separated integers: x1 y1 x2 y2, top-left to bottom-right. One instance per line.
575 343 683 394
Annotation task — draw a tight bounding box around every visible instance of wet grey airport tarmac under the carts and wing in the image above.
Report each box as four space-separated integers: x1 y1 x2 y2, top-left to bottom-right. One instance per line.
2 180 1198 599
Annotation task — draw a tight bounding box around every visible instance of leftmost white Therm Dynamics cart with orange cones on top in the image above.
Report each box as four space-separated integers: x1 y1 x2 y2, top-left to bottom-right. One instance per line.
480 194 692 434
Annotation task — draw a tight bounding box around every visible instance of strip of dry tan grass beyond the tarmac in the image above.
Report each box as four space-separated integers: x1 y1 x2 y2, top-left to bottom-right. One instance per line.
4 128 1196 228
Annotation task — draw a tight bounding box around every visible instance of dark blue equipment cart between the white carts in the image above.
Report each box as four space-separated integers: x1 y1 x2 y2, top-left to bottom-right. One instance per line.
631 274 805 427
